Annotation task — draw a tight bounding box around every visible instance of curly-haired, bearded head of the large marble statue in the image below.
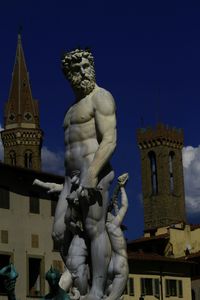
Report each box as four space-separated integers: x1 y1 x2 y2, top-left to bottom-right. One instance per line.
62 49 95 95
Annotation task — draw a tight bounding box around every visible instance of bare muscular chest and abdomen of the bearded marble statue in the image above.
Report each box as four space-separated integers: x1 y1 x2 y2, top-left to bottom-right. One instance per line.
64 87 98 172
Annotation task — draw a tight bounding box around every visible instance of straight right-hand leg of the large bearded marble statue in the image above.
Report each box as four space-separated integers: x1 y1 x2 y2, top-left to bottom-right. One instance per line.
81 172 114 300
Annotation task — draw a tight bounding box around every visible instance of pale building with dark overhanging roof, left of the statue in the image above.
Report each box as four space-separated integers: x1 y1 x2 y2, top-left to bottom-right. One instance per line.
0 163 64 300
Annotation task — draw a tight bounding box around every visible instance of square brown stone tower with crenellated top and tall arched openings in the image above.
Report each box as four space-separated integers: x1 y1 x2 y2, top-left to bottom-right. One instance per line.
137 124 186 232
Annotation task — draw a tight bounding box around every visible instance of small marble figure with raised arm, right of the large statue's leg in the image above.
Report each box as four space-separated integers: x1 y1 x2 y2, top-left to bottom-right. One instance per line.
106 173 128 300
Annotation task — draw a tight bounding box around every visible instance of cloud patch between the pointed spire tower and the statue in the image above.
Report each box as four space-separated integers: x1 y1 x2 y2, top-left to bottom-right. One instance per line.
41 147 64 175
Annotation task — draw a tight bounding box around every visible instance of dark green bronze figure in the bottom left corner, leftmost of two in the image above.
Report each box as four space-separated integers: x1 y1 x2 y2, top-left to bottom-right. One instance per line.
0 264 18 300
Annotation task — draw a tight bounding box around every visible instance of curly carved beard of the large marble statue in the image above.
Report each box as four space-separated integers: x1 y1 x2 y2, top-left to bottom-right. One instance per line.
70 75 95 95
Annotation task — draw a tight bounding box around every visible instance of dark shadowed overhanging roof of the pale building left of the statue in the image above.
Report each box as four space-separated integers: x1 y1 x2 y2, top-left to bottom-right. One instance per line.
0 162 64 199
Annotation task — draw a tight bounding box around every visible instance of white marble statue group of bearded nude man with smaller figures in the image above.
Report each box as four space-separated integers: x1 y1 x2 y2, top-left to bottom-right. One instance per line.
35 49 128 300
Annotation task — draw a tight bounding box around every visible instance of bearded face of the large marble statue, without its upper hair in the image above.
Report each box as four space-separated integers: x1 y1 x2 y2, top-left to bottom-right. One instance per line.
68 57 95 94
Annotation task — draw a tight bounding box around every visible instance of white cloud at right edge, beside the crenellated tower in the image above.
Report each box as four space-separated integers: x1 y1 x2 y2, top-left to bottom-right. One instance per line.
182 146 200 213
